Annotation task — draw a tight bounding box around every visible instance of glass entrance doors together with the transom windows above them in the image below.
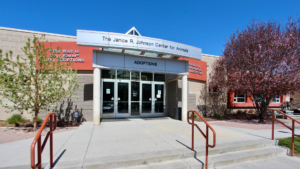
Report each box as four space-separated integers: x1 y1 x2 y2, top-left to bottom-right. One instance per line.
101 70 166 118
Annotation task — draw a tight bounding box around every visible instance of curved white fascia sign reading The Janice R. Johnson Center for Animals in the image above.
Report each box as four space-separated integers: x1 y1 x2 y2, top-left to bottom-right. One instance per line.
77 30 202 59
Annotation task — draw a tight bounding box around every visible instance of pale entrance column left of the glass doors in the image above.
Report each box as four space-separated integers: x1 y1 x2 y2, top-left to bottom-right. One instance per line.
93 68 101 126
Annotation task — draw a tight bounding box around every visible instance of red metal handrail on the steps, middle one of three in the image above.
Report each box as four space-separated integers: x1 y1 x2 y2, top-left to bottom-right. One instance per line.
187 110 216 169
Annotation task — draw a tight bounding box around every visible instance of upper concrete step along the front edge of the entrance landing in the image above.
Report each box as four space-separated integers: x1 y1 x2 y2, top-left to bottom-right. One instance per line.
46 139 285 169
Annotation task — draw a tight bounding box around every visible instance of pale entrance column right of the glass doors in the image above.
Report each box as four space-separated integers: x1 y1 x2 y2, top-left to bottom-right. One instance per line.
181 75 187 121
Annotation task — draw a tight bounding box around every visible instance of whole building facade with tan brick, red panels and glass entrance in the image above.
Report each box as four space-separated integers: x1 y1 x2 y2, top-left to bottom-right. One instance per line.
0 27 286 125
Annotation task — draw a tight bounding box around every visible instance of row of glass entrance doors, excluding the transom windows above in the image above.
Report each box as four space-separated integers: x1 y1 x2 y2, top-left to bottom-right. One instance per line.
102 79 165 117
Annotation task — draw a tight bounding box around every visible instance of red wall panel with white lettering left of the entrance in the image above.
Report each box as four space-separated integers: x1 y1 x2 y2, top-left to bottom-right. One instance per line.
44 42 96 70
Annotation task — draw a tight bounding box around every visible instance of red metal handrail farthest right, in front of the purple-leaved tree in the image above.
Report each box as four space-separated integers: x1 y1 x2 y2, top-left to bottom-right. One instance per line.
265 109 300 156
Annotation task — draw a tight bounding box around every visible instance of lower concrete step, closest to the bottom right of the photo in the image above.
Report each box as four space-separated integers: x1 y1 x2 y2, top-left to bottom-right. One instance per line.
118 146 286 169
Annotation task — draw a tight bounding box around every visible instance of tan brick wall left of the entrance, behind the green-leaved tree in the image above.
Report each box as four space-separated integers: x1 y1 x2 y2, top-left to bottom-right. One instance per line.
0 27 93 121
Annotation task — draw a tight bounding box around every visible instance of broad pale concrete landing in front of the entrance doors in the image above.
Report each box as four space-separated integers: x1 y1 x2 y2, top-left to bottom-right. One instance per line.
0 117 298 169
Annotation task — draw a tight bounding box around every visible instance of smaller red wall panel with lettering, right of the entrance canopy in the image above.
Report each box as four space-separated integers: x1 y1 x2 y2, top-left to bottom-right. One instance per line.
178 57 206 81
